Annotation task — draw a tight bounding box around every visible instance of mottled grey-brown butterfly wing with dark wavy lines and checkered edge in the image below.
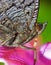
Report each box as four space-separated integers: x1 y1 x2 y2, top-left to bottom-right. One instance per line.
0 0 39 46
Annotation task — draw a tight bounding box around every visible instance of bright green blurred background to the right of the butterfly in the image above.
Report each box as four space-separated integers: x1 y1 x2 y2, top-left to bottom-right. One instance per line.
38 0 51 43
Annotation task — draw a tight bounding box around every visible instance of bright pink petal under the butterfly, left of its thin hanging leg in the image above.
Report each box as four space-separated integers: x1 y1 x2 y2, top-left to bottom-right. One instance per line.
0 41 34 65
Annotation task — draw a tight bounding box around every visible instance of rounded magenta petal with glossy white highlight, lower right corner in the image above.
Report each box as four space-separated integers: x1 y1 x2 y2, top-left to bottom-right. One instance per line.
39 42 51 65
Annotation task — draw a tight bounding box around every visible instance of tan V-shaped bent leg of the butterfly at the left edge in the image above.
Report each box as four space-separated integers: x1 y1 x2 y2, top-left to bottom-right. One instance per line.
0 24 13 46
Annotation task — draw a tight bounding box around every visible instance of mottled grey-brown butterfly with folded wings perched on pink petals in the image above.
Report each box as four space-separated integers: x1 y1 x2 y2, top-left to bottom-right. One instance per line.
0 0 47 49
